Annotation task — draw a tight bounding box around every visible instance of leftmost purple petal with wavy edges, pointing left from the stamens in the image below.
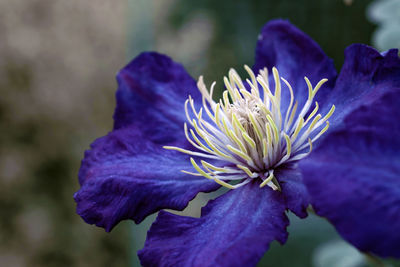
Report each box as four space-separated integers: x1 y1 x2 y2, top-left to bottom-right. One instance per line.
74 128 219 231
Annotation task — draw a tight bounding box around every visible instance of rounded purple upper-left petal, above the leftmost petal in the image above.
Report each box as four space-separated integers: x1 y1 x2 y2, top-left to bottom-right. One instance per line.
114 52 201 144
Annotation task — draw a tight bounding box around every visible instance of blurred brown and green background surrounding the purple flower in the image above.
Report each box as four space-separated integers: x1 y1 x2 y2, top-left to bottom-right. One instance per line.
0 0 400 267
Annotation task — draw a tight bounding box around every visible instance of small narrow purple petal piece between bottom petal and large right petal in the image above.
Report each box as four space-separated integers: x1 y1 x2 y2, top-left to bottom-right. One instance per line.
274 167 310 218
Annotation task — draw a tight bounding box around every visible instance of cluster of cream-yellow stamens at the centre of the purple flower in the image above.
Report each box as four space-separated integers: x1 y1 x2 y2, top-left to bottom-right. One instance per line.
164 66 335 190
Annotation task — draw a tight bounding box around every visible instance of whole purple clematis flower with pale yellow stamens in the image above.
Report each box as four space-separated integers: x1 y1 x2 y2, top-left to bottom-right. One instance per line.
74 20 400 266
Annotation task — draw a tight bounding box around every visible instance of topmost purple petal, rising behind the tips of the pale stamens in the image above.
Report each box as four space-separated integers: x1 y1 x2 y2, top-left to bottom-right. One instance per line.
253 20 336 108
